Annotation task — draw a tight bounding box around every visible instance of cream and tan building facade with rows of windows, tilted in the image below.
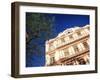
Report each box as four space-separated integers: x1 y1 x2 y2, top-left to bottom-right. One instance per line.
45 25 90 66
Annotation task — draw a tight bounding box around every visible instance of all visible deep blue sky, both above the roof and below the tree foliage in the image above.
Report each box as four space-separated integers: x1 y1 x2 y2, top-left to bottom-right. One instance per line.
26 13 90 67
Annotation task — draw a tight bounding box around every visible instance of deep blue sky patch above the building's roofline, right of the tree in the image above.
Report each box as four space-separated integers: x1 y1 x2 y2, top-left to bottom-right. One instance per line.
49 14 89 33
